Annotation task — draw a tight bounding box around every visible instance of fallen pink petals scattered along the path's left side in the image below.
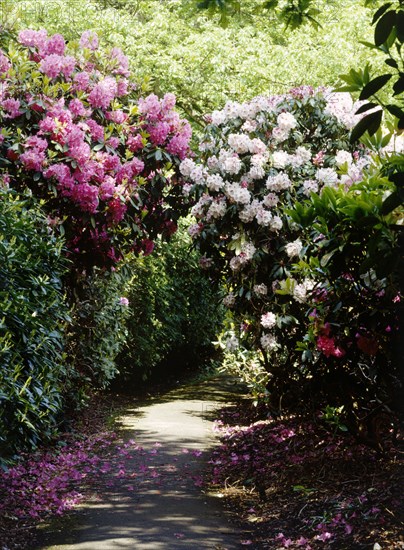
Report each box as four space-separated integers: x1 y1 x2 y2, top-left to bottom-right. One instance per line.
0 432 208 538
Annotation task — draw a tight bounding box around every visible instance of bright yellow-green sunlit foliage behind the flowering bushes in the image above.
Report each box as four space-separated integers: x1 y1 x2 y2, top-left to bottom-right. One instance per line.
3 0 381 128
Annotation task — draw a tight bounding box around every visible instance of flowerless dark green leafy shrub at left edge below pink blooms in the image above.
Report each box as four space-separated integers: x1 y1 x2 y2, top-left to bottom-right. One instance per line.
0 189 68 460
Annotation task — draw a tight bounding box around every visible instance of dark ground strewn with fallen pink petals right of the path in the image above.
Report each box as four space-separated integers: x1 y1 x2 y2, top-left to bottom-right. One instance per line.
209 406 400 550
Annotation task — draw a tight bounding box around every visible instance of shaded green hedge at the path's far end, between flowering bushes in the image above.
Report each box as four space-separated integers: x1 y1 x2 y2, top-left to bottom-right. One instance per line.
117 222 223 381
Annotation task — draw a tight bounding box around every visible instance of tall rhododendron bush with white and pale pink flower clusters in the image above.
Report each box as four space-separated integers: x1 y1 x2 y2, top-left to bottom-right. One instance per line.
180 87 369 380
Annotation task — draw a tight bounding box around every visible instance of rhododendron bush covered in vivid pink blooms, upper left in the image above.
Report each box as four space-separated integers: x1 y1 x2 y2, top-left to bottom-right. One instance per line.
0 29 191 269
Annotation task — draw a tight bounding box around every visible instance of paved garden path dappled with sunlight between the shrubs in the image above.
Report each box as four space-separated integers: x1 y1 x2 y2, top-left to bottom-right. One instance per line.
37 379 248 550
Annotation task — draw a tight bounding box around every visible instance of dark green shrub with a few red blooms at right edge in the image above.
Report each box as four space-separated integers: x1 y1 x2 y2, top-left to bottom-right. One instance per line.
283 169 403 442
